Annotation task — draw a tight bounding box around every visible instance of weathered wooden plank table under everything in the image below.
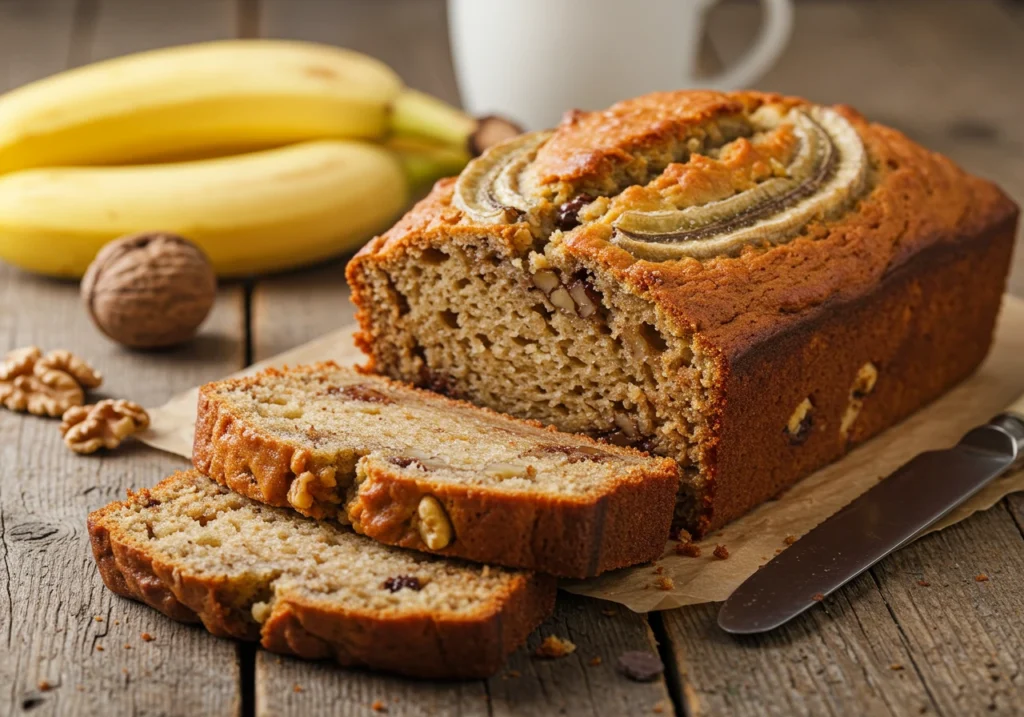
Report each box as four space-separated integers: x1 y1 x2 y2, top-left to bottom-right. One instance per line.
0 0 1024 715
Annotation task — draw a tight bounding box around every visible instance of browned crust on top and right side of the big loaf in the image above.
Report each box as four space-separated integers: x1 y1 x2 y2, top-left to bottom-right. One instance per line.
347 91 1018 533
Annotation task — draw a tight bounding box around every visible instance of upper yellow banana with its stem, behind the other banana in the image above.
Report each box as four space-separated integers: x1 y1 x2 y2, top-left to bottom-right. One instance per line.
0 40 512 174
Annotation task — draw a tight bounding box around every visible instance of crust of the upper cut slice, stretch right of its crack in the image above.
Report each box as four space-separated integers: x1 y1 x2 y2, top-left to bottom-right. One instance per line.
348 460 679 578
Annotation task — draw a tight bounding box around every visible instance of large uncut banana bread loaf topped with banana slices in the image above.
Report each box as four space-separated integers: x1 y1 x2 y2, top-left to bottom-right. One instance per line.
347 91 1017 535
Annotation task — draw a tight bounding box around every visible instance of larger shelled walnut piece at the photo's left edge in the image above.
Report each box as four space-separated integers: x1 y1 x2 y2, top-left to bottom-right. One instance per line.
0 346 102 417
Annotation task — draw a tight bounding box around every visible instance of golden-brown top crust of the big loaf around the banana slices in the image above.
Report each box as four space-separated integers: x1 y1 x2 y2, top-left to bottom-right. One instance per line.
346 91 1016 356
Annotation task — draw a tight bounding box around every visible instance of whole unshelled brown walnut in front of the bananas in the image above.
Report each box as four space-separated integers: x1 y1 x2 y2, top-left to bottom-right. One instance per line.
82 233 217 348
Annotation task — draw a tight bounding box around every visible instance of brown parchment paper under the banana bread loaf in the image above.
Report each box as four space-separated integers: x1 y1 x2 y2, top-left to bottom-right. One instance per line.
141 296 1024 613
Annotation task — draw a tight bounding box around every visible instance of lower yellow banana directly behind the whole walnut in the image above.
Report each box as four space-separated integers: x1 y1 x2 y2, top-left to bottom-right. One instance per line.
0 140 408 277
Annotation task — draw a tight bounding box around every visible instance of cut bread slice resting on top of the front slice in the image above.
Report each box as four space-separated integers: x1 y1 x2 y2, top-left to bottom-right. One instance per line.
193 364 679 578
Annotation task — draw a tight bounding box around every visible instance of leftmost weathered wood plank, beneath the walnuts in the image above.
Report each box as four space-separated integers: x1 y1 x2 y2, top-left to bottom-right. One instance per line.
0 0 245 715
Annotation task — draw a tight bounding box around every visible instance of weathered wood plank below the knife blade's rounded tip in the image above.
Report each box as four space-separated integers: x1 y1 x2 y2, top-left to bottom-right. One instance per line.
664 576 934 716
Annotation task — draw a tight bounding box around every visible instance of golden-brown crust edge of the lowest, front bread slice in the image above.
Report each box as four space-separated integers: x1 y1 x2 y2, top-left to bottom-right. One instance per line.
88 475 555 678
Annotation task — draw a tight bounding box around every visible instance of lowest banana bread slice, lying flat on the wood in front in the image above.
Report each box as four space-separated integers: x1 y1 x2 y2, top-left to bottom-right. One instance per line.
89 471 555 678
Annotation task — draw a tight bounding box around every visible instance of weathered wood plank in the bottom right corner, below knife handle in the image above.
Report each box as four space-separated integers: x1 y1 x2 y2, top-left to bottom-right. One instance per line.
872 505 1024 715
